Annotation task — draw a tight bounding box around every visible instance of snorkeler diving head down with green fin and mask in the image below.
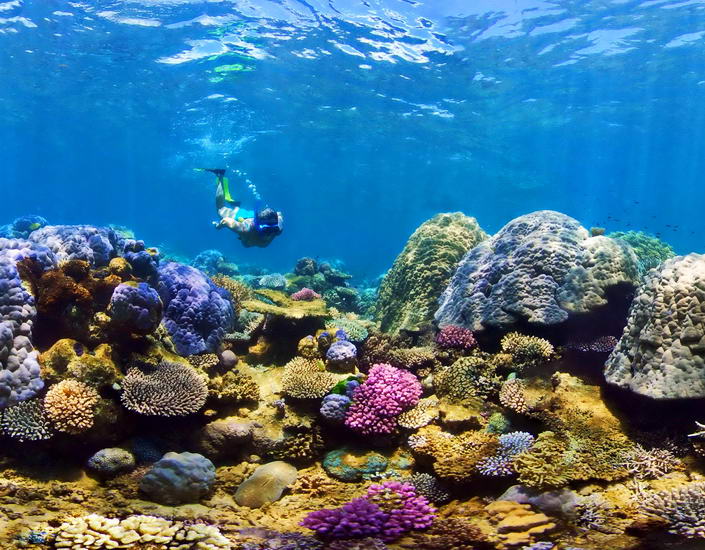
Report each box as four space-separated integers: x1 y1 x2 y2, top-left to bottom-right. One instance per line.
202 168 284 248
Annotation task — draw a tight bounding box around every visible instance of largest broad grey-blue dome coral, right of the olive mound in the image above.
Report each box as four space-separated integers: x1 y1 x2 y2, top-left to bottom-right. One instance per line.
435 210 639 330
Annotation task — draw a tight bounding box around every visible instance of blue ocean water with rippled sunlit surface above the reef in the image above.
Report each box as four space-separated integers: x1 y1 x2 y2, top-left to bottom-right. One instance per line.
0 0 705 276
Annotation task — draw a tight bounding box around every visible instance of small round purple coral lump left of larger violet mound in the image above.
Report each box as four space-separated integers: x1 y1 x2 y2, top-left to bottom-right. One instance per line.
108 283 162 334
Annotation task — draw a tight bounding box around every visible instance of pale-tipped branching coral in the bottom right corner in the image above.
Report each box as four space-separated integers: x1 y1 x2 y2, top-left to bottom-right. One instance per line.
641 481 705 539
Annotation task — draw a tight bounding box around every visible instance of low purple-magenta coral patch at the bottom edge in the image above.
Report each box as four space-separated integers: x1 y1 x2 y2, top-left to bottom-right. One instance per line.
301 481 435 542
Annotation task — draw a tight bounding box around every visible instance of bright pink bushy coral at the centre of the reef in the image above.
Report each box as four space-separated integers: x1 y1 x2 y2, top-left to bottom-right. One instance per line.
345 364 423 435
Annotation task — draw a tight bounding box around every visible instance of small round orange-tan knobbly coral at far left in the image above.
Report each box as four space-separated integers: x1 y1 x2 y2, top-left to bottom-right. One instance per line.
44 379 99 434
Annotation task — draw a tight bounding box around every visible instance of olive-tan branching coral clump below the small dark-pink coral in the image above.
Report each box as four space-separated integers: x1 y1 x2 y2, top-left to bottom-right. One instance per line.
433 355 501 402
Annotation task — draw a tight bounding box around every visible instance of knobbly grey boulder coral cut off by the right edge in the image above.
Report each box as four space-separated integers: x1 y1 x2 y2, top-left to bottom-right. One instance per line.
605 254 705 399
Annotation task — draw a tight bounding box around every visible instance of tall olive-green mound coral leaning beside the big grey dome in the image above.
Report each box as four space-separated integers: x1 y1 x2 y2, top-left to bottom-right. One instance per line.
376 212 487 333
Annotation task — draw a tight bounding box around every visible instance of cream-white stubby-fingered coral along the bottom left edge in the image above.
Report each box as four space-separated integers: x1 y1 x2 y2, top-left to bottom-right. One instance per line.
54 514 232 550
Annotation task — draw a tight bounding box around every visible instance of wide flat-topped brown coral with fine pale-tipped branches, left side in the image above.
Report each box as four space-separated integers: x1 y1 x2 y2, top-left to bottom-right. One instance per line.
122 361 208 416
